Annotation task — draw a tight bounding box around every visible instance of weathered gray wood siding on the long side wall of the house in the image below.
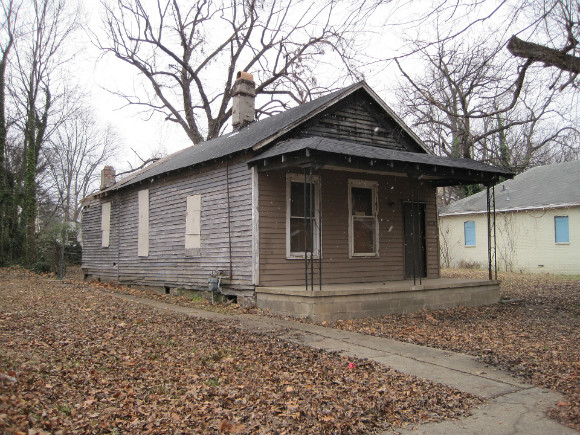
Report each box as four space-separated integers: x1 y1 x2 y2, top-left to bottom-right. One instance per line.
83 159 252 288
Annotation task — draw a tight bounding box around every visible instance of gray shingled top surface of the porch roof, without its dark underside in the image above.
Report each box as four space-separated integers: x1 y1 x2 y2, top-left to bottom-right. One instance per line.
250 136 511 176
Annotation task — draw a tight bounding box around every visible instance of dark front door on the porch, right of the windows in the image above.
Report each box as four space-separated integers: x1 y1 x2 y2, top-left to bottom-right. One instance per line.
403 203 427 278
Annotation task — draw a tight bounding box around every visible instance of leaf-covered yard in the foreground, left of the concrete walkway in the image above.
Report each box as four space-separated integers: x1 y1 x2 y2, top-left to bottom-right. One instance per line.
0 269 480 435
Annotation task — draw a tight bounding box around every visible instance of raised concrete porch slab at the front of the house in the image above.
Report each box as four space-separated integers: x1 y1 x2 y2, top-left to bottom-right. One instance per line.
256 278 500 321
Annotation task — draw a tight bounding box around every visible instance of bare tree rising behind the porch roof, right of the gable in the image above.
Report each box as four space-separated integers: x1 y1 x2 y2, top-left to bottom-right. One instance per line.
398 37 576 172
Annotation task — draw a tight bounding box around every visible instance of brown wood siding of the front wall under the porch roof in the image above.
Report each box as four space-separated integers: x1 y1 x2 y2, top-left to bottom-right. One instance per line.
259 170 439 286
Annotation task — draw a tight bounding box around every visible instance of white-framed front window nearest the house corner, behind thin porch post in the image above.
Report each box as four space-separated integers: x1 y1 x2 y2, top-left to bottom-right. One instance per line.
286 174 319 258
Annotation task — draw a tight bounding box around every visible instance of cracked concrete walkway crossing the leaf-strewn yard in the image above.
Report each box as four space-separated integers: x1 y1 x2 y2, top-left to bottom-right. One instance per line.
114 294 580 435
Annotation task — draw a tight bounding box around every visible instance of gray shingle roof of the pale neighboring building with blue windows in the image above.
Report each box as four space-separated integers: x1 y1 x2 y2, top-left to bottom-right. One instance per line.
440 161 580 215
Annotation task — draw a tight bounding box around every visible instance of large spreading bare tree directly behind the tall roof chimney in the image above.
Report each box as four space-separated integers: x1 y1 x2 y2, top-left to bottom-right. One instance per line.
95 0 372 143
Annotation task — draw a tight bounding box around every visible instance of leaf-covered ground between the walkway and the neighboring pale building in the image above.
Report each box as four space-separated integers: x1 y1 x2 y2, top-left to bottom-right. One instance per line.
328 270 580 430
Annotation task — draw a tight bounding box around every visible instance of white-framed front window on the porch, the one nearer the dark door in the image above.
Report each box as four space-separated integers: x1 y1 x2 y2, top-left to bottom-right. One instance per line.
348 180 379 257
